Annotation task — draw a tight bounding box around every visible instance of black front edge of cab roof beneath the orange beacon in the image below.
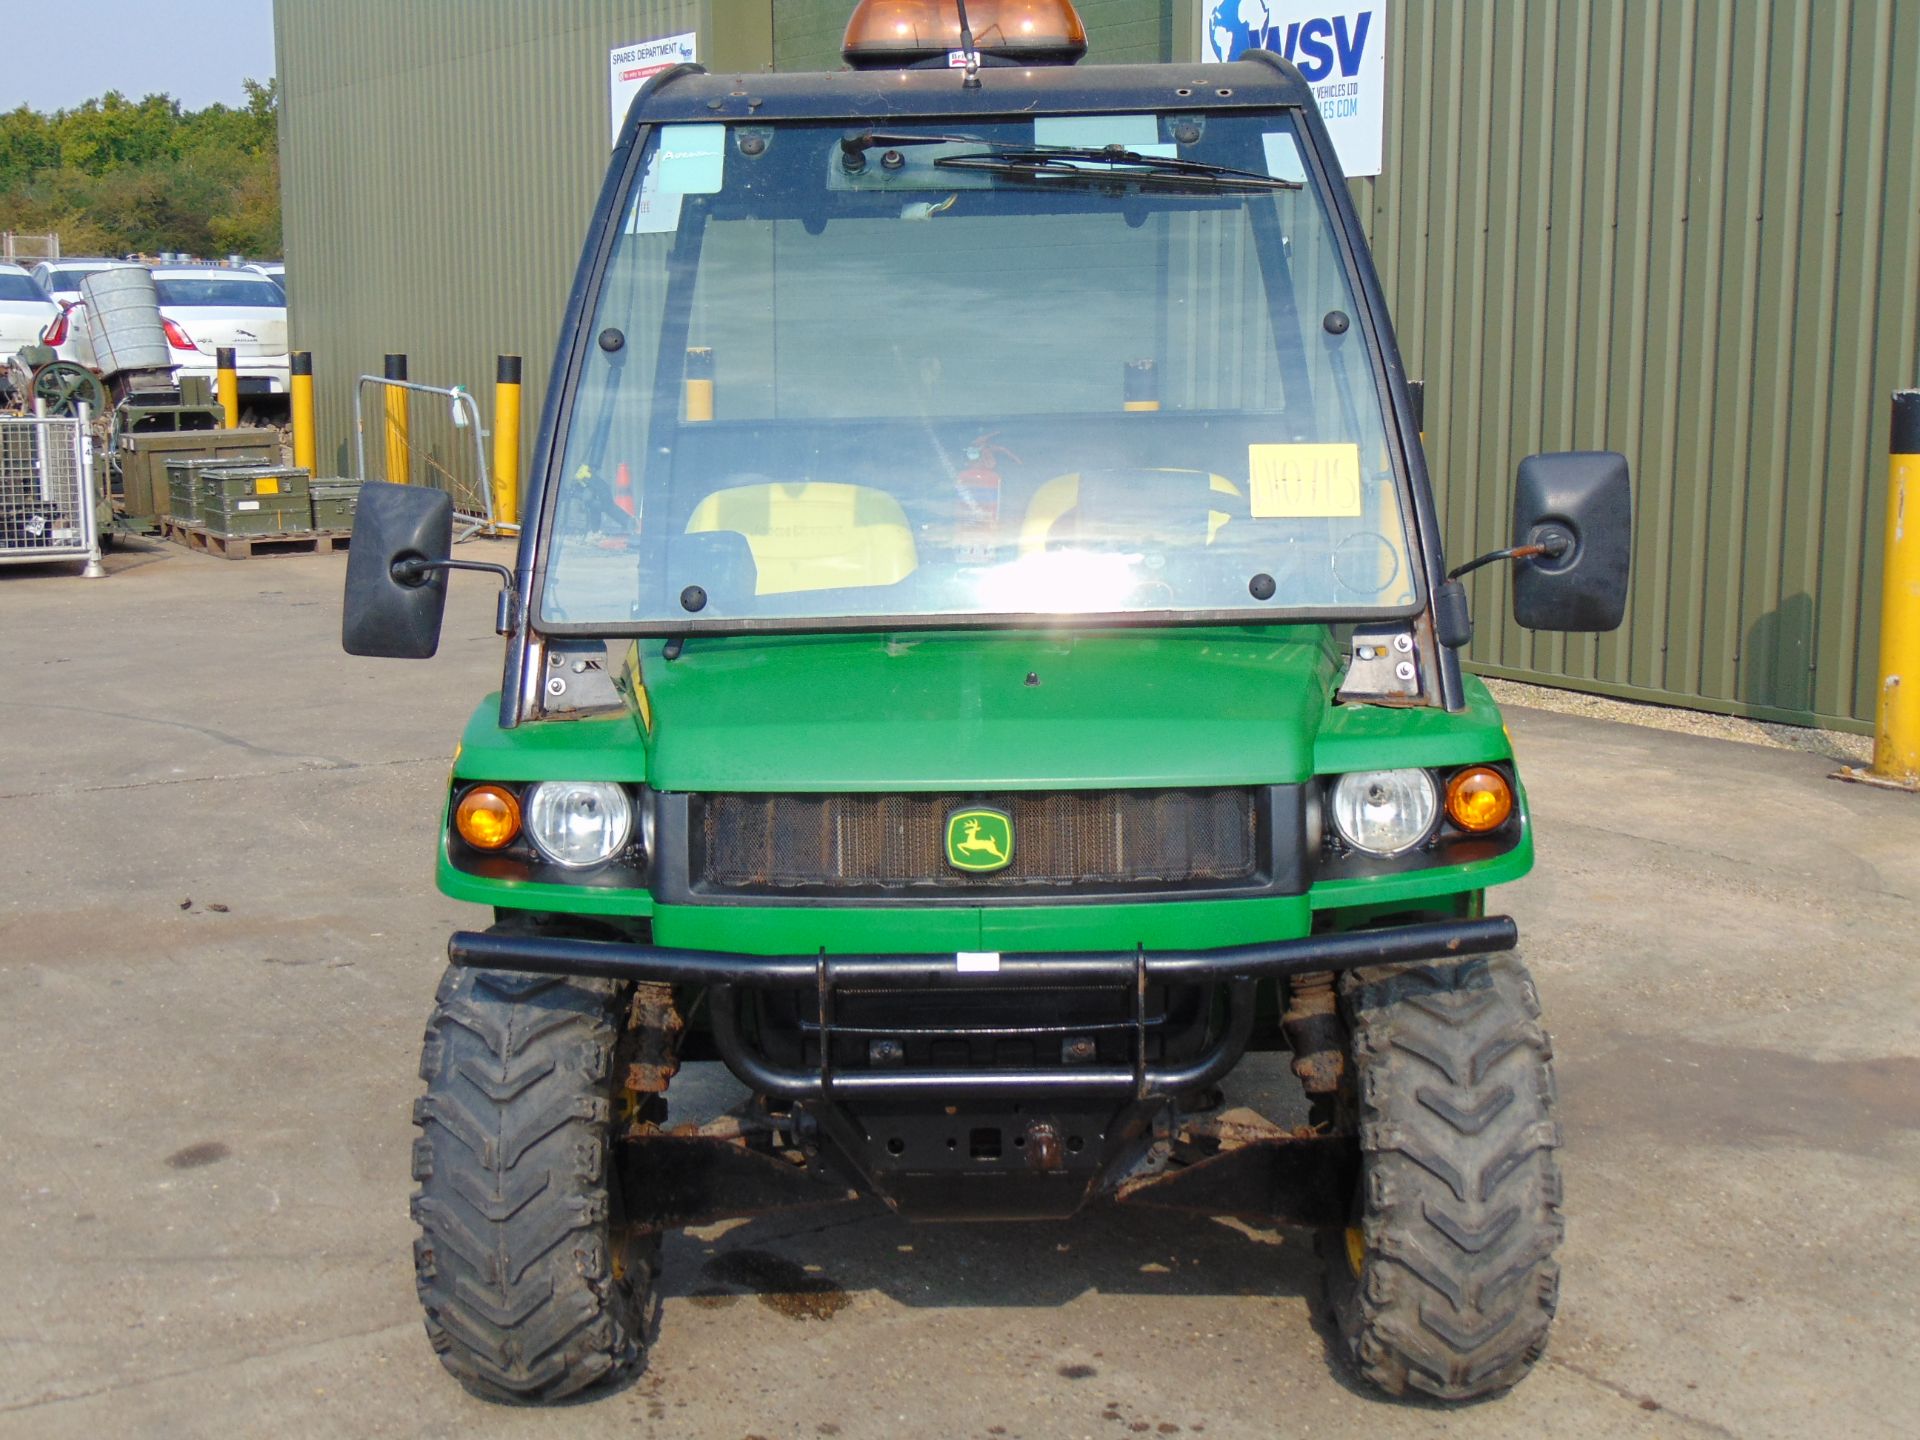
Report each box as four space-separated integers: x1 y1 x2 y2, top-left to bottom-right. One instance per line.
622 50 1315 138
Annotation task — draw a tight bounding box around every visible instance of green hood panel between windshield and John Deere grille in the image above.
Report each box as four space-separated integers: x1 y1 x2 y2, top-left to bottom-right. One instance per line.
639 626 1334 791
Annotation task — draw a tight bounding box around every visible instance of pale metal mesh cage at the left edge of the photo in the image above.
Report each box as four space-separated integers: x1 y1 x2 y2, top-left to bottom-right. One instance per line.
0 405 106 576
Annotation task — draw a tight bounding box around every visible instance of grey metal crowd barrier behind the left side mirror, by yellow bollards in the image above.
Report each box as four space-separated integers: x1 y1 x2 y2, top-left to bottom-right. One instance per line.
353 374 495 540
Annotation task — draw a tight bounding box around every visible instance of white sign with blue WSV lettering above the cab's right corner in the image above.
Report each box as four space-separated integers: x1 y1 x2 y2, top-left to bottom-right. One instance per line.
1200 0 1388 175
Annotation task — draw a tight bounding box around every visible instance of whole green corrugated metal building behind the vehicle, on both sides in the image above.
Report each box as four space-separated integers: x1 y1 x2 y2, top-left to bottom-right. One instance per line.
275 0 1920 730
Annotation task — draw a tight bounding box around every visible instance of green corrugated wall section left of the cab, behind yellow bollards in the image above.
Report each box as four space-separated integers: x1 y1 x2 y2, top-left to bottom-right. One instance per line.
275 0 772 485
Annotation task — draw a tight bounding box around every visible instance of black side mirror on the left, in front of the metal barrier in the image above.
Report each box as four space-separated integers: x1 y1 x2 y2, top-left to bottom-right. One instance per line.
340 480 453 660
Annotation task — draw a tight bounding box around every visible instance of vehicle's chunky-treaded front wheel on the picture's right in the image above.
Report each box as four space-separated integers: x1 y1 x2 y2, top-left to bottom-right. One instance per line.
1323 958 1563 1402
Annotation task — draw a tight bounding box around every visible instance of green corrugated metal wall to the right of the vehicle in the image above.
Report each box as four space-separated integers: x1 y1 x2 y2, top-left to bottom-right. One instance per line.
1356 0 1920 728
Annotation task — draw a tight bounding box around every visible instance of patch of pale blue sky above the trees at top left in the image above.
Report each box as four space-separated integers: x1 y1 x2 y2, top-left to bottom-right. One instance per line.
0 0 273 111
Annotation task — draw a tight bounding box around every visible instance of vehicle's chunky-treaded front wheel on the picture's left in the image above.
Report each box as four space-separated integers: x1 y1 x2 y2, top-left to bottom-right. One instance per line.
413 968 659 1402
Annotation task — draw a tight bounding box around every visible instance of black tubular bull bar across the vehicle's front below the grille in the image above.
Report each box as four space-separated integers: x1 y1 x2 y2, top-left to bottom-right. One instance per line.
447 916 1519 1100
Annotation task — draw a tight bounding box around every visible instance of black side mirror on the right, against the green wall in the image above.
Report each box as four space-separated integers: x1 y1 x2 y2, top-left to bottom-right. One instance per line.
1513 449 1634 630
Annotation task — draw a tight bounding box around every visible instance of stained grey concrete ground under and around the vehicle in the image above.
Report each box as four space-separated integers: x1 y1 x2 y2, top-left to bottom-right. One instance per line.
0 543 1920 1440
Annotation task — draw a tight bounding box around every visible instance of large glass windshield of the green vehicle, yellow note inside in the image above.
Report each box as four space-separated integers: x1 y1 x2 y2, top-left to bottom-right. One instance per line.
536 113 1417 630
